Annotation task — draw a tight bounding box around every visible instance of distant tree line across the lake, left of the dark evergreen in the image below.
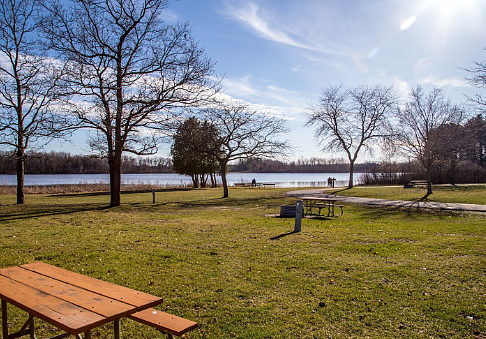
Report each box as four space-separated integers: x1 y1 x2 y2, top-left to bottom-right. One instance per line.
0 151 172 174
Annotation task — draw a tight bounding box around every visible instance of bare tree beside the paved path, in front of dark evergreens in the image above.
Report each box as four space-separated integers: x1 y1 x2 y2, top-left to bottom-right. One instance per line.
396 86 464 194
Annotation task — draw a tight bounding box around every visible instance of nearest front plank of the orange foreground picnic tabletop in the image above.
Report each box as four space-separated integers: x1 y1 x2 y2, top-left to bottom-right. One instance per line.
0 275 106 334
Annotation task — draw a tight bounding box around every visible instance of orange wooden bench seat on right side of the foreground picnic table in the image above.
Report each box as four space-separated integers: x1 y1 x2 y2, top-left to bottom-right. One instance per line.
128 308 198 339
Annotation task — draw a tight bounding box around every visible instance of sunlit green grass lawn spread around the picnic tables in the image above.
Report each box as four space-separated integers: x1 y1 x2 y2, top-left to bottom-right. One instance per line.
0 189 486 338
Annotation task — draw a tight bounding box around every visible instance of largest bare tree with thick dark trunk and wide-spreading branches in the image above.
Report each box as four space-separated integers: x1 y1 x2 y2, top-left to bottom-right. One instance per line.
43 0 219 206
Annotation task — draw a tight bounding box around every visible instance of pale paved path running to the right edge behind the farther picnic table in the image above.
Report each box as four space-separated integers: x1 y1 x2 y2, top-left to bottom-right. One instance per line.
286 189 486 213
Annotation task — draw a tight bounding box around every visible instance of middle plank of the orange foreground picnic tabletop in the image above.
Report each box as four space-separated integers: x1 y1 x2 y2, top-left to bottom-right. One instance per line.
0 267 133 320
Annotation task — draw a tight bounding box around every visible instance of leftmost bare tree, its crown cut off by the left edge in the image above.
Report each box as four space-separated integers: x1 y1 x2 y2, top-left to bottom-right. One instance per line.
0 0 68 204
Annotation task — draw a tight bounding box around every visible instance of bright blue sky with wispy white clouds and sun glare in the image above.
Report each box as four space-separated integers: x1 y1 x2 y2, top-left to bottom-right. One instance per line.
53 0 486 162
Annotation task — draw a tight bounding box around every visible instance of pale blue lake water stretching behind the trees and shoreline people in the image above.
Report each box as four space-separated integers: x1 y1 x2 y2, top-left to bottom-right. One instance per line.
0 173 360 187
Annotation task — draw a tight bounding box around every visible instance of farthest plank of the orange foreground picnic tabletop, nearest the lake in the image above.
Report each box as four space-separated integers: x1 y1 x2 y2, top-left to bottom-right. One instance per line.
20 262 162 307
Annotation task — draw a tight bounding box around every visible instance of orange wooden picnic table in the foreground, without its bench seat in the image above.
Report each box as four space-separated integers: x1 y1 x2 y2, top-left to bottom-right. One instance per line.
0 262 162 339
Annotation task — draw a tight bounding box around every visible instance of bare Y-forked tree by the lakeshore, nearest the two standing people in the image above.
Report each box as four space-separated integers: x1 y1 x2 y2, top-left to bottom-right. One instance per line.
307 85 396 188
